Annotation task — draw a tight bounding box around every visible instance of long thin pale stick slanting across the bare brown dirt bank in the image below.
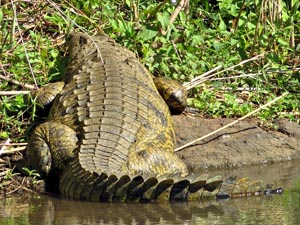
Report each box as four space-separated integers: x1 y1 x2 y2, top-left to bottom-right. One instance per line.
174 92 288 152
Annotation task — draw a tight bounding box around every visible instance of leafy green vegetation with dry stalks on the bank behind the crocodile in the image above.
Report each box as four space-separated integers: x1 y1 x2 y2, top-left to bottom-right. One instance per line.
0 0 300 142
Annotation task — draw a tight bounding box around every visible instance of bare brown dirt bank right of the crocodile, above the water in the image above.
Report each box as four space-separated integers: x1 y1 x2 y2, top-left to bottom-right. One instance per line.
173 115 300 169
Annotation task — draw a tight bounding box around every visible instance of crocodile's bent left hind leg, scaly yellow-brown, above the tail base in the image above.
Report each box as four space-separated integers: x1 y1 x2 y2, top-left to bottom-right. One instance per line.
27 122 78 177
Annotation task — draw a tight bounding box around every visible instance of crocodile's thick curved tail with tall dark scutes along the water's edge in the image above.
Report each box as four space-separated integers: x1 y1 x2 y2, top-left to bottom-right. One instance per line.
60 162 222 202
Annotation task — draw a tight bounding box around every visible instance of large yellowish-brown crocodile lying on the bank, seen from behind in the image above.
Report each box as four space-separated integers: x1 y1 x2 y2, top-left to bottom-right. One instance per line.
27 33 278 201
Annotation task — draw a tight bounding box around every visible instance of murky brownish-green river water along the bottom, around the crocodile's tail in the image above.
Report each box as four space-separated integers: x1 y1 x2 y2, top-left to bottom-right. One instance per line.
0 161 300 225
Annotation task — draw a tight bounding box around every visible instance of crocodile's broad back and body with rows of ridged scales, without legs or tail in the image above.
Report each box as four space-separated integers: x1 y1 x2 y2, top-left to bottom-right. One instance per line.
50 34 186 176
